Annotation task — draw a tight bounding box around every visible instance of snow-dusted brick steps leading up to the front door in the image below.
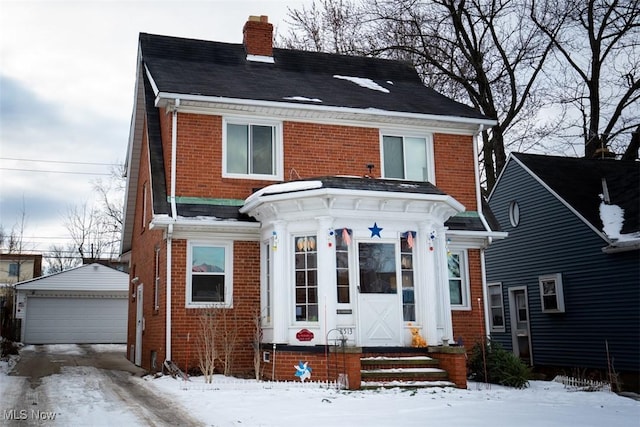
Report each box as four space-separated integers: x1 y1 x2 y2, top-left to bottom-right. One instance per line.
360 356 455 389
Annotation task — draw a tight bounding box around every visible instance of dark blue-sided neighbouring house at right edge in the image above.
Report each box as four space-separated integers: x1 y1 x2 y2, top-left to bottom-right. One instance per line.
486 153 640 388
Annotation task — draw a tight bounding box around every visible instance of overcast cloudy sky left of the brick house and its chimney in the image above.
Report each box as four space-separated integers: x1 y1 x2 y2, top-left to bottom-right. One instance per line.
0 0 312 251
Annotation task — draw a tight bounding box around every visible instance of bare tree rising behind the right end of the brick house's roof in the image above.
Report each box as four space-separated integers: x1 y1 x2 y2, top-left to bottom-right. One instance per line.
285 0 554 190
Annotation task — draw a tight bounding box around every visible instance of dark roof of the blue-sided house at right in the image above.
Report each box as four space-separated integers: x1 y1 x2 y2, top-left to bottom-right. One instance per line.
512 153 640 234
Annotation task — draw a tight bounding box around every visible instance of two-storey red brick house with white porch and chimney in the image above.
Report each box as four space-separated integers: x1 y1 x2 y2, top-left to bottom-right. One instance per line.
122 16 504 388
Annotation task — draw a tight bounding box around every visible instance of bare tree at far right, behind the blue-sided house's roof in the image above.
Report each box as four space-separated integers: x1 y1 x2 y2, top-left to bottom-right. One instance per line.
531 0 640 158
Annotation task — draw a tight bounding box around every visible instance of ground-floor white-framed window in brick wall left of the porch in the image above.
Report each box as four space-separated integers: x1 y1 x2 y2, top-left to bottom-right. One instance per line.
187 242 233 307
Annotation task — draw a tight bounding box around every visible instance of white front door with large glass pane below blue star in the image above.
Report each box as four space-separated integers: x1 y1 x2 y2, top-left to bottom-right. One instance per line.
358 243 402 346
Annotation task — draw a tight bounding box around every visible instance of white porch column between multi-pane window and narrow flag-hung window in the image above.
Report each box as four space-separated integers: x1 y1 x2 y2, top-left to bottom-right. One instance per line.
316 216 337 344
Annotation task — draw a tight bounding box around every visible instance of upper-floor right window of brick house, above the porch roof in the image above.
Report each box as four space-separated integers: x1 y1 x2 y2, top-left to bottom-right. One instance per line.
382 134 433 181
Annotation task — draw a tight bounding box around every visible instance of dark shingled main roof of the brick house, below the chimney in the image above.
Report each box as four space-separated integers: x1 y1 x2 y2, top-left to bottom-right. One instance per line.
140 33 487 120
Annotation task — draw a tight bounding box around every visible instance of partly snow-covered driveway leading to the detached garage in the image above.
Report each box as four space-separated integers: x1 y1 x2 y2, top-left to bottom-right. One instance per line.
0 345 203 426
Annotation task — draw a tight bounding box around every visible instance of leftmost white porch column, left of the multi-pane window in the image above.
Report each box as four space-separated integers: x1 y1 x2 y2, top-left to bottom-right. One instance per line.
271 221 292 343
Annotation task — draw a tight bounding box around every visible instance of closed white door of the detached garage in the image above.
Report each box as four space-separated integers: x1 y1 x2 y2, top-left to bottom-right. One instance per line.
24 297 127 344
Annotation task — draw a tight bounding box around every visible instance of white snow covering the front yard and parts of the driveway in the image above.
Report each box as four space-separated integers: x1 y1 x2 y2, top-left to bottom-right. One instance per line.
0 346 640 427
